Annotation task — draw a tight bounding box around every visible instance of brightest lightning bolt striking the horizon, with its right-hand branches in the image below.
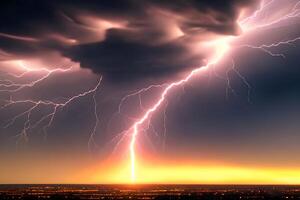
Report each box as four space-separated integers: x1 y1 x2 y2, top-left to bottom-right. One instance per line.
124 0 300 182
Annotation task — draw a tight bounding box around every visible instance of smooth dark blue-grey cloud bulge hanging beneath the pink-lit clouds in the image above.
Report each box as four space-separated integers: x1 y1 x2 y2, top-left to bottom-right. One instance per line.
67 30 199 80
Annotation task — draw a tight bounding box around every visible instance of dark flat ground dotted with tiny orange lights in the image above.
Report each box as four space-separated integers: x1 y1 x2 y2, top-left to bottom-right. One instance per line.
0 185 300 200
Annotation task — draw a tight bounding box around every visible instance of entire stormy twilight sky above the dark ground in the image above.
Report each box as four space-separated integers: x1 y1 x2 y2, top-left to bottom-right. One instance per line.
0 0 300 183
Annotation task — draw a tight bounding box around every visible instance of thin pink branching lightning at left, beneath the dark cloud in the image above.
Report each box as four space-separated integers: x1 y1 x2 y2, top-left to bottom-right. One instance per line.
0 61 102 148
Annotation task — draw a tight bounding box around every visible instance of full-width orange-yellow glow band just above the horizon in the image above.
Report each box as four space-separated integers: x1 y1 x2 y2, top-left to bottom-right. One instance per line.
0 155 300 185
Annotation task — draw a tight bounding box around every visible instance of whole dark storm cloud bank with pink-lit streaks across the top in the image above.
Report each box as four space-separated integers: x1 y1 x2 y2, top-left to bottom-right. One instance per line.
0 0 256 81
